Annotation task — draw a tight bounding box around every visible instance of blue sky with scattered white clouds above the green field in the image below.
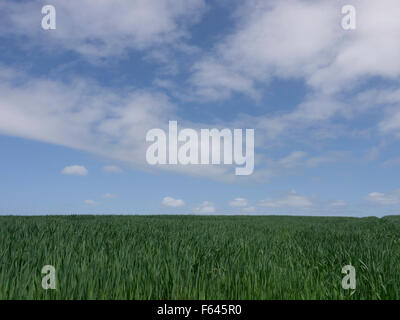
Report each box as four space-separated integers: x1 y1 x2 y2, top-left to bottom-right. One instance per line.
0 0 400 217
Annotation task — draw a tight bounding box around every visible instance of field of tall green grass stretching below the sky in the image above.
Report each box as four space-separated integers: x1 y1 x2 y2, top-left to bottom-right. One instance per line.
0 216 400 299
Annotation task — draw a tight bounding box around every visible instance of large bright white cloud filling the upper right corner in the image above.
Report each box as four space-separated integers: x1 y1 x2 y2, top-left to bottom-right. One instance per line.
191 0 400 97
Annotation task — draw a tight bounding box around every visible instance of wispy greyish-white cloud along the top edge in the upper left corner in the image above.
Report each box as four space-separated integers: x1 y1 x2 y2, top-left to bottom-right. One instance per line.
0 0 205 58
